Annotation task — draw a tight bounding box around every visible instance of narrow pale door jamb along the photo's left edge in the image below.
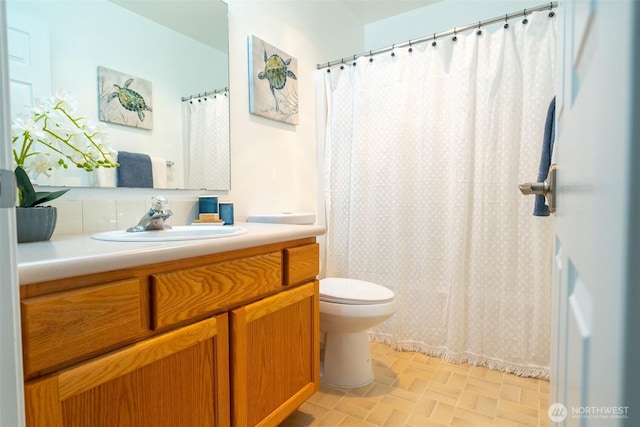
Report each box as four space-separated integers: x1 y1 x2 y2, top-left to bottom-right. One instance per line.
0 2 24 427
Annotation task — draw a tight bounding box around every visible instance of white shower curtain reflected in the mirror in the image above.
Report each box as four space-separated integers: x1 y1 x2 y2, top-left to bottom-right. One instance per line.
183 94 230 190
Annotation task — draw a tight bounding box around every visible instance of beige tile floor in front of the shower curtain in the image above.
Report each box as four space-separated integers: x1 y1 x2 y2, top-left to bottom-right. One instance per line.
280 342 549 427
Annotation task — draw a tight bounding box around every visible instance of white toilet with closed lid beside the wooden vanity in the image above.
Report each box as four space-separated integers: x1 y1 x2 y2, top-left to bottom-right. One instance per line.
247 213 396 388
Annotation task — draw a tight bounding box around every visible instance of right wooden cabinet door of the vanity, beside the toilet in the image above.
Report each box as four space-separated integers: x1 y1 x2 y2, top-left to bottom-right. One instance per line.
230 280 320 426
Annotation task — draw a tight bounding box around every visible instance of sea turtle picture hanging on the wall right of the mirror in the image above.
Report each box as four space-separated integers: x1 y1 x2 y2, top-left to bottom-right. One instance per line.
248 35 298 125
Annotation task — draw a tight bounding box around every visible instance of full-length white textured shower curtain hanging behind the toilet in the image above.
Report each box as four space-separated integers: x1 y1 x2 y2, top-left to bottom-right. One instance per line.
318 13 557 377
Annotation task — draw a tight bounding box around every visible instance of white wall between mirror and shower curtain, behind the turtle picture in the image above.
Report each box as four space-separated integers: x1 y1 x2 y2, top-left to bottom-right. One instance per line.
228 0 364 219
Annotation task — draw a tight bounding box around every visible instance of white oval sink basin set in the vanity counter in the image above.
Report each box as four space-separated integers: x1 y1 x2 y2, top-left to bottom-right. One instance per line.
91 225 247 242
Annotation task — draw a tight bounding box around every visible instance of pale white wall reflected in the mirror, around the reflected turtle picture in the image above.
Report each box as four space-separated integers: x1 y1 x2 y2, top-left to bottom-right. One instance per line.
7 0 228 188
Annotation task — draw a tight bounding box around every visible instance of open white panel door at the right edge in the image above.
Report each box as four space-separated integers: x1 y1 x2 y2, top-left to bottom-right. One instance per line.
549 0 640 426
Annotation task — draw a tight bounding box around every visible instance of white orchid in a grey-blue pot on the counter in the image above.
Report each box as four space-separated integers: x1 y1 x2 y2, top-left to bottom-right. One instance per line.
11 91 118 243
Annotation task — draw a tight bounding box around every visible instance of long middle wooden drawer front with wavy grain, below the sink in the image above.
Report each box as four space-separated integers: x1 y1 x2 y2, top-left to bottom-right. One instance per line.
151 252 282 329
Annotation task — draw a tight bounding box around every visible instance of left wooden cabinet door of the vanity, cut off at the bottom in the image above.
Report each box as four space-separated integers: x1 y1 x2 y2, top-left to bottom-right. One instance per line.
25 313 230 427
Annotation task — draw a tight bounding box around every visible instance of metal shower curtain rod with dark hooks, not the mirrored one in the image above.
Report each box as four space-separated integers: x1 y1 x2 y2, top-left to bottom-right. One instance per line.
317 1 558 70
